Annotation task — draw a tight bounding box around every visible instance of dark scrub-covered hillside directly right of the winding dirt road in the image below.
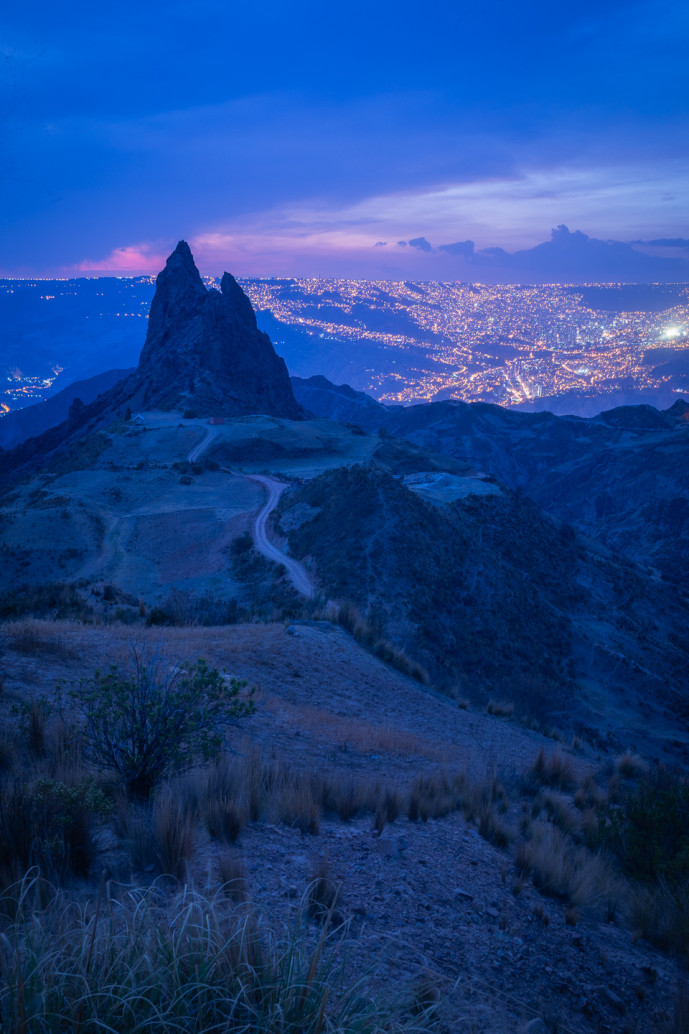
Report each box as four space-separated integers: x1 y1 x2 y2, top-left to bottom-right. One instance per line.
279 467 689 753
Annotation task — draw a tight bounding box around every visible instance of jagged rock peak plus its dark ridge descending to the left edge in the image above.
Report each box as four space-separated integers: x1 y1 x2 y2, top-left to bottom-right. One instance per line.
0 241 305 481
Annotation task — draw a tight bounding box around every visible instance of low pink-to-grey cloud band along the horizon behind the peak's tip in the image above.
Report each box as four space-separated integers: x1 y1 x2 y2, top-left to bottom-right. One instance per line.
67 219 689 283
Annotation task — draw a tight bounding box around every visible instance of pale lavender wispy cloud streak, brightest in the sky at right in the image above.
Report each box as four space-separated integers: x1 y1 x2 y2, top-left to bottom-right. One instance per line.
247 162 689 260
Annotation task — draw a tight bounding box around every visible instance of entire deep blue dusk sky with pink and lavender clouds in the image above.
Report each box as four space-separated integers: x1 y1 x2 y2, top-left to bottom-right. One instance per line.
0 0 689 282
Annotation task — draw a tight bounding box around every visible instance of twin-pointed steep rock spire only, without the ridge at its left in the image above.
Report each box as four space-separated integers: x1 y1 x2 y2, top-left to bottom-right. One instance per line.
137 241 302 420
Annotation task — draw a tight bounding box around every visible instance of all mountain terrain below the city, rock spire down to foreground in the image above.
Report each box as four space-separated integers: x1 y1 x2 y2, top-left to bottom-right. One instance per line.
0 256 689 1034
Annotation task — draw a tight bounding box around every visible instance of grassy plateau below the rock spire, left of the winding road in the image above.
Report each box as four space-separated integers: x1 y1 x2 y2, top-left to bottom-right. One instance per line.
0 412 379 606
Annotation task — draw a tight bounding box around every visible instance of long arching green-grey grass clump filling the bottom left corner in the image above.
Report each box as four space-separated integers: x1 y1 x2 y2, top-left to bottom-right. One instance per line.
0 881 420 1034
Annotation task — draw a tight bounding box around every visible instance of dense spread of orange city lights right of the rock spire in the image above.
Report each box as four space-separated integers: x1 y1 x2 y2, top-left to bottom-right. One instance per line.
244 279 689 405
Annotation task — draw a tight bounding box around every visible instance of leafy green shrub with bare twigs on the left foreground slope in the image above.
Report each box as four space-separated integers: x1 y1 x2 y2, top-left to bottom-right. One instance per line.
73 649 254 799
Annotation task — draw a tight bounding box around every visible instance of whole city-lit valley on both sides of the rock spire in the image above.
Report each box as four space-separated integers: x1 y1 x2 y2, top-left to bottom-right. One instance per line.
0 277 689 413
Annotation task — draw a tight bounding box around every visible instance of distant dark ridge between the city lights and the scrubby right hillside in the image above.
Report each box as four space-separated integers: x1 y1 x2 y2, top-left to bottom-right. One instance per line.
294 378 689 591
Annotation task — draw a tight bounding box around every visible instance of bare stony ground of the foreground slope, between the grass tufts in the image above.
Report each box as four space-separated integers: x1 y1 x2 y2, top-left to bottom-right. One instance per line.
0 620 684 1034
